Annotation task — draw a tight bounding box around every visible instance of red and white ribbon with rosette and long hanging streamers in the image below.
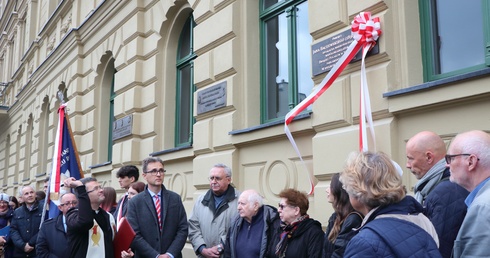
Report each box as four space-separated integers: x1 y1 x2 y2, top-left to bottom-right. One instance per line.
284 12 381 194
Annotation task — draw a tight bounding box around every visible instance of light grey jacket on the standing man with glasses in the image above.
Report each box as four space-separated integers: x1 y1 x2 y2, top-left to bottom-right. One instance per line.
189 185 240 257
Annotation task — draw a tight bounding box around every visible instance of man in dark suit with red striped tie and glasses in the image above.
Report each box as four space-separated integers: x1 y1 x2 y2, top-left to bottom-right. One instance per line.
127 157 188 258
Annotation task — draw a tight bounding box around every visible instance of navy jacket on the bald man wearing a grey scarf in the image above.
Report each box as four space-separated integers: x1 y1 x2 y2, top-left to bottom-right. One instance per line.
424 168 469 258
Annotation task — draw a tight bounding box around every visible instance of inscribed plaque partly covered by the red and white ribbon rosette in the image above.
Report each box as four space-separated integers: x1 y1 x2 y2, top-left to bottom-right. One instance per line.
311 29 379 76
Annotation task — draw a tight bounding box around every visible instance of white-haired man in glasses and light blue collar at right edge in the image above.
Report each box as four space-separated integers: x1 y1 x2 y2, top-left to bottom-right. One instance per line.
446 131 490 258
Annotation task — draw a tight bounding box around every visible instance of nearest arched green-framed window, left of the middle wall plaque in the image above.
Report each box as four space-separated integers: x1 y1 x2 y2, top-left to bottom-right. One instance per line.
175 15 196 147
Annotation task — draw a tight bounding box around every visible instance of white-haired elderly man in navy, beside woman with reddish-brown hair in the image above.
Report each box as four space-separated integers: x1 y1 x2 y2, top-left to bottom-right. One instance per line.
225 190 279 258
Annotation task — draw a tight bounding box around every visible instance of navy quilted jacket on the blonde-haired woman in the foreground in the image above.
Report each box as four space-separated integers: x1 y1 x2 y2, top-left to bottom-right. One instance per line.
344 196 441 258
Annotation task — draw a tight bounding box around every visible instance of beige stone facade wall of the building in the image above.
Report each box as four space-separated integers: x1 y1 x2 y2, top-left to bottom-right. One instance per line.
0 0 490 255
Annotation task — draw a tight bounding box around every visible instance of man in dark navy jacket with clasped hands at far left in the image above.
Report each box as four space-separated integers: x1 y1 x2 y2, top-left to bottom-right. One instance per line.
10 186 44 257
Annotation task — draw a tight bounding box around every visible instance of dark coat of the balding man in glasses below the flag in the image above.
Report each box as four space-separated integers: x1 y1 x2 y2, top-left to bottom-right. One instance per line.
36 213 70 258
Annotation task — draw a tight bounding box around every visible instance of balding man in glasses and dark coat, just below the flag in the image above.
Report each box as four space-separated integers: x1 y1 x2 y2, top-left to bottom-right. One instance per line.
36 193 78 257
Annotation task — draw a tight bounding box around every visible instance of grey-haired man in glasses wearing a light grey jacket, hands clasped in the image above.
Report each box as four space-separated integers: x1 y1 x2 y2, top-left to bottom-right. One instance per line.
189 164 240 258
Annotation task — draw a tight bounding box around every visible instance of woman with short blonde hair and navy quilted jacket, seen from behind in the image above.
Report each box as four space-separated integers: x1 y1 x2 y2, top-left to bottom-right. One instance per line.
340 152 441 257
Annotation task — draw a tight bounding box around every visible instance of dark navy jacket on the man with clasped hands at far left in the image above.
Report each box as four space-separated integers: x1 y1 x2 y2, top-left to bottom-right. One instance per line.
10 201 44 257
